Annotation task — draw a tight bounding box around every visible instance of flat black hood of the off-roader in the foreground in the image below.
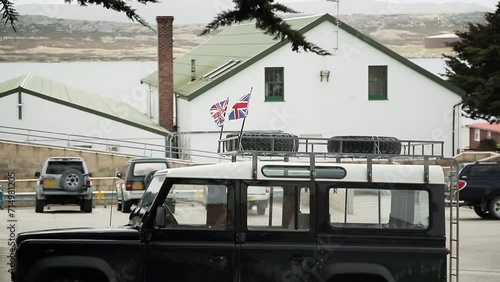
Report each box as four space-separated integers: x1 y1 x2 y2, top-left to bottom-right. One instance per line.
16 225 139 245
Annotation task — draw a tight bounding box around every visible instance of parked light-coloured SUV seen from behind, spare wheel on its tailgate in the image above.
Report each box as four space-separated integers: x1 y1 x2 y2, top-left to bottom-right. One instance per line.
35 157 93 213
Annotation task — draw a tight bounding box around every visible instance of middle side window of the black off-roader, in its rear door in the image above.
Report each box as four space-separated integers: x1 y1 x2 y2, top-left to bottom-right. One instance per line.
246 186 310 231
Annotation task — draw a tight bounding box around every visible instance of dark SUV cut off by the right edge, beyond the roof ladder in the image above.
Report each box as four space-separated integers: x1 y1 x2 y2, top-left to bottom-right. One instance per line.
458 162 500 219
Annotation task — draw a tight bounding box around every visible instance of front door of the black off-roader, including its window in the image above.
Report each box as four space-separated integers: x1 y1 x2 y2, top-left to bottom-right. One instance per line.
146 180 235 282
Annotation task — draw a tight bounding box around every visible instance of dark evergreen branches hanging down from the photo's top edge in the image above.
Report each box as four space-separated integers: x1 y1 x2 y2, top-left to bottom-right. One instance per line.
0 0 331 56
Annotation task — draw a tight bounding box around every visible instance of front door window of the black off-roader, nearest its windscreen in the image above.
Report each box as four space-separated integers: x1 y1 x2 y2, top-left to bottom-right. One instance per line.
164 184 228 230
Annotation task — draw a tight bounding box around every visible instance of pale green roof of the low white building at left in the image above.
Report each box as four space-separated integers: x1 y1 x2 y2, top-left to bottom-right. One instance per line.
0 74 168 135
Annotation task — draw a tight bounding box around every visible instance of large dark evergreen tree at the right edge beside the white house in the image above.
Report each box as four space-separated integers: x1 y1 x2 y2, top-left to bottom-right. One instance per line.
445 2 500 122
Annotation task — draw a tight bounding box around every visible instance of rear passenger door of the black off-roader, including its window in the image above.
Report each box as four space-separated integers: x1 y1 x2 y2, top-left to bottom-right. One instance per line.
236 181 315 282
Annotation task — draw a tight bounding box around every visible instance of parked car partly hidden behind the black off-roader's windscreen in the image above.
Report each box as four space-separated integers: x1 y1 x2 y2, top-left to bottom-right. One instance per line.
115 157 173 213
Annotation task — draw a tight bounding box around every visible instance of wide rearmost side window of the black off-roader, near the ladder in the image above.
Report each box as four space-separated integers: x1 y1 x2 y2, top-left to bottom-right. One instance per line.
328 187 430 229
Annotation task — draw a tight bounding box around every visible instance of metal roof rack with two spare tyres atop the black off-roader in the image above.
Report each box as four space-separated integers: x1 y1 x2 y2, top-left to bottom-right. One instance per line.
219 134 452 183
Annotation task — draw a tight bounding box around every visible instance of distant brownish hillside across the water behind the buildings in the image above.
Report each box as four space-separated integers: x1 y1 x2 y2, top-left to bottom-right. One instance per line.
0 12 484 62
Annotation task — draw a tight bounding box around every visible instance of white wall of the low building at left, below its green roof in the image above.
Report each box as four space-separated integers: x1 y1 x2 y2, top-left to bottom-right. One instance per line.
0 93 165 156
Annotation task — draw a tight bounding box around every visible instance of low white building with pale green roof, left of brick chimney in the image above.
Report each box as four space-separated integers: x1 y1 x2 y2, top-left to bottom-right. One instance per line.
0 74 168 156
